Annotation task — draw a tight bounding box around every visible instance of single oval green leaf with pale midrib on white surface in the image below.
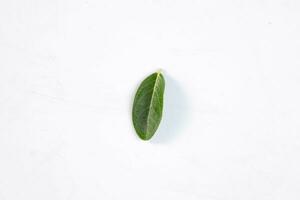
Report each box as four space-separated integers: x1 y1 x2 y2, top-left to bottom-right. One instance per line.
132 71 165 140
